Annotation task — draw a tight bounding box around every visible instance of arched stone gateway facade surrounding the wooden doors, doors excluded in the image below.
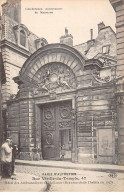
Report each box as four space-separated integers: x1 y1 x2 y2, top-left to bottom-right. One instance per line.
8 44 117 163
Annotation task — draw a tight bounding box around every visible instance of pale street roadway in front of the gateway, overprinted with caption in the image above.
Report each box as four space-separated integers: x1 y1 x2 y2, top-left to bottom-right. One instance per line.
15 165 124 192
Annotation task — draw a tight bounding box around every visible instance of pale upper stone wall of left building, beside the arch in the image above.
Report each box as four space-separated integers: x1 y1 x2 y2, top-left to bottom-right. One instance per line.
2 48 28 102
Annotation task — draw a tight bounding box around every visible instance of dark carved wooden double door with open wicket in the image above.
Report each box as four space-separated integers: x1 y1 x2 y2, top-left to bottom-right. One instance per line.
41 101 72 160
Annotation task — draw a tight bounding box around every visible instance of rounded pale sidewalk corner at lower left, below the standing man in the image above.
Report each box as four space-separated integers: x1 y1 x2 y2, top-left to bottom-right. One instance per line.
0 173 47 192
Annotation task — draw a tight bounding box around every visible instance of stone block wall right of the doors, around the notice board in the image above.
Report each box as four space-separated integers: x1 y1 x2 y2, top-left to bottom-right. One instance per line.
77 86 117 163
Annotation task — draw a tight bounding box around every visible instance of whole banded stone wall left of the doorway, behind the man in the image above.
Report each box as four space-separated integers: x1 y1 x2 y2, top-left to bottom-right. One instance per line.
7 96 35 160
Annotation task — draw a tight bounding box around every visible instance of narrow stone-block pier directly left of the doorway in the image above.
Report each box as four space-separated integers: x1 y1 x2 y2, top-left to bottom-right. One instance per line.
20 100 35 160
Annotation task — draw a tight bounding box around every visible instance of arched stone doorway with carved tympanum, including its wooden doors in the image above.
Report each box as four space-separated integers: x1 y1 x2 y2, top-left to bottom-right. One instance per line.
11 44 85 161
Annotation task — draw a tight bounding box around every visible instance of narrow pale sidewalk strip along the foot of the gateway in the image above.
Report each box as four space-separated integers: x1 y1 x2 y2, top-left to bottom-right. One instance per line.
16 160 124 173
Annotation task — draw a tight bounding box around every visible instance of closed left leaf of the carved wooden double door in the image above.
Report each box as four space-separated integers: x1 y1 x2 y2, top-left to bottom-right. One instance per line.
42 104 60 159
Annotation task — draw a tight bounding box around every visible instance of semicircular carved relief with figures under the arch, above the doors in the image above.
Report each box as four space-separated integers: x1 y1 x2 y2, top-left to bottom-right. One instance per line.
33 63 76 94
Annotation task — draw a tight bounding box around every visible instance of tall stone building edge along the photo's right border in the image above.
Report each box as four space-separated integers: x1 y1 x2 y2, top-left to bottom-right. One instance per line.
110 0 124 165
